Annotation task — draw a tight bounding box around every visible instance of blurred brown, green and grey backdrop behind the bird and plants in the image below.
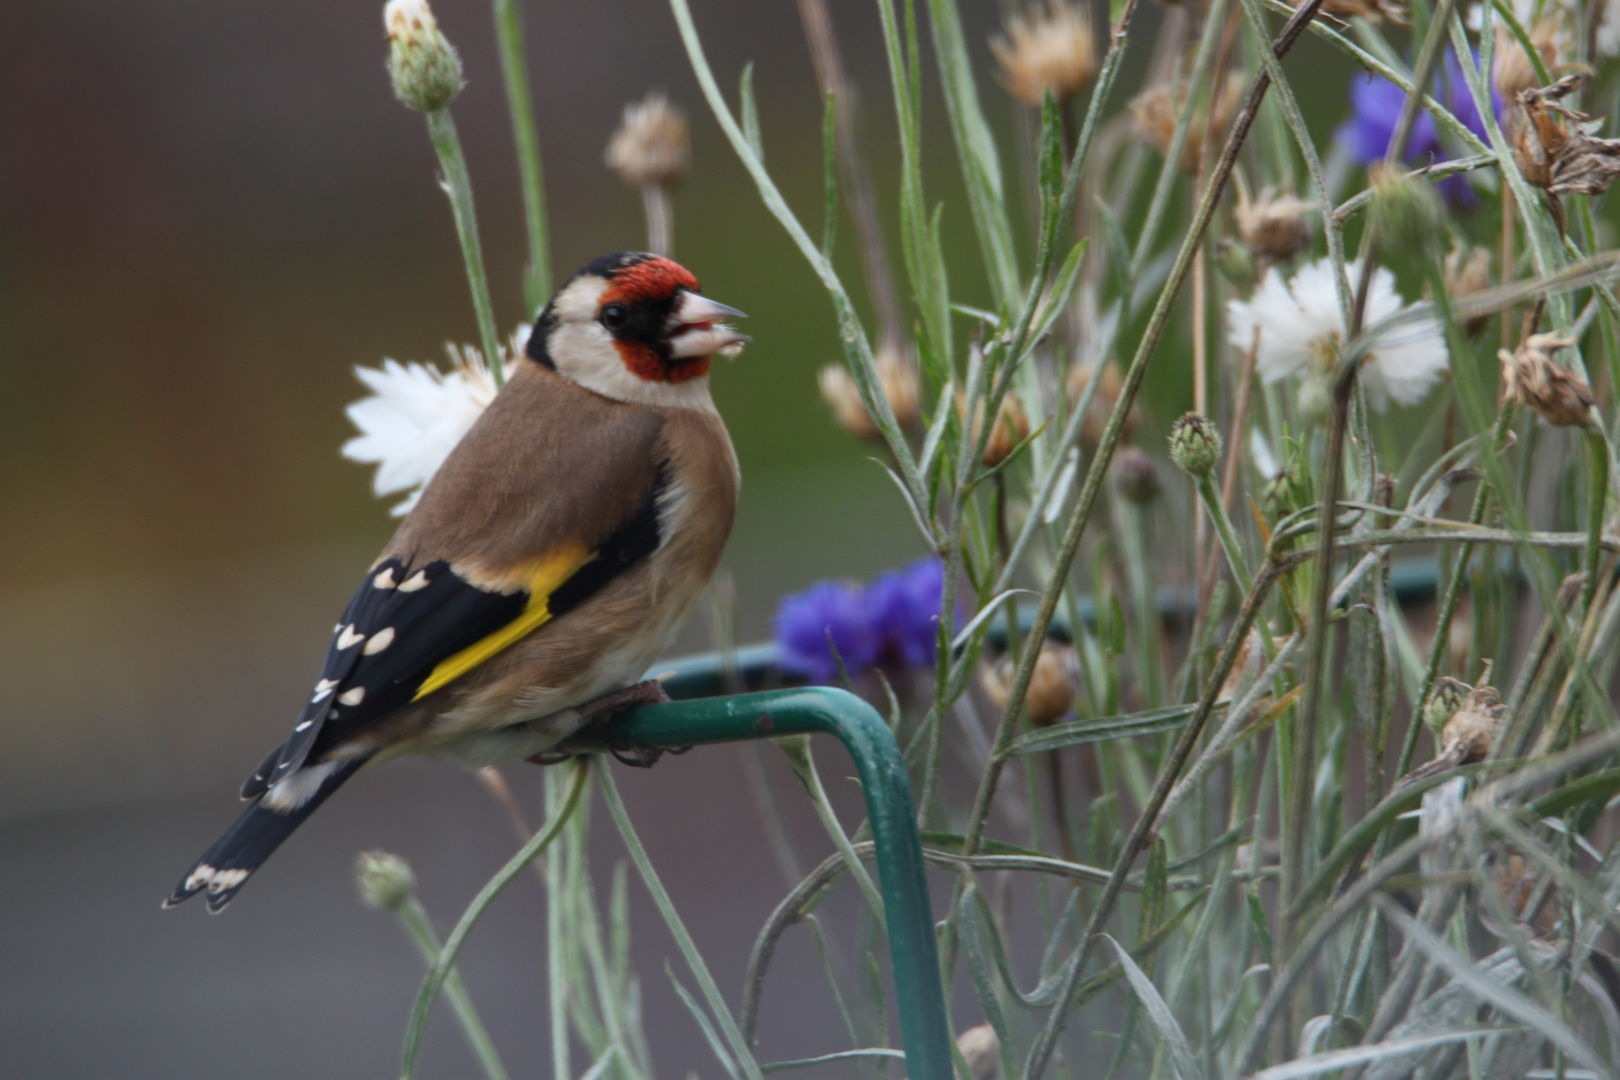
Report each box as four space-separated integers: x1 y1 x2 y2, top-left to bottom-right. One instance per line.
0 0 1348 1078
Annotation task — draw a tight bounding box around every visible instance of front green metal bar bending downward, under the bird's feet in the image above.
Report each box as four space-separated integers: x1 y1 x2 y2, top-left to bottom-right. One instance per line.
569 687 953 1080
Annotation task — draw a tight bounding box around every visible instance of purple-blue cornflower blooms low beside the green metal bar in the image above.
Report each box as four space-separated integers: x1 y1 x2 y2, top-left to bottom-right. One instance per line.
774 559 944 683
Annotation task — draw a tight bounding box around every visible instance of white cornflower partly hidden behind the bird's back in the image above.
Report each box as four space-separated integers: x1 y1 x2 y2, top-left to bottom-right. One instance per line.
343 327 528 518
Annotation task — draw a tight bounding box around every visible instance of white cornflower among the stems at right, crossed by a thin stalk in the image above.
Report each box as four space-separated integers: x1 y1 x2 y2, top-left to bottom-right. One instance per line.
1226 259 1450 411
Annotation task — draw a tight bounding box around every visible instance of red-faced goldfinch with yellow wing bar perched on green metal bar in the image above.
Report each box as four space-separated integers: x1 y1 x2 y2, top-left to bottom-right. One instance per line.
165 251 748 912
